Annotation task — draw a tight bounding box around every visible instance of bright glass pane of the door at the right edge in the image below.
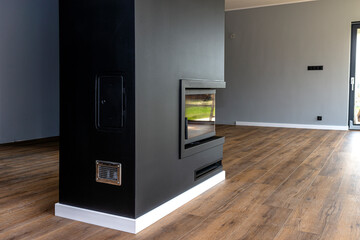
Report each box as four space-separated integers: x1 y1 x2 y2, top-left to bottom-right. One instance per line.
354 29 360 124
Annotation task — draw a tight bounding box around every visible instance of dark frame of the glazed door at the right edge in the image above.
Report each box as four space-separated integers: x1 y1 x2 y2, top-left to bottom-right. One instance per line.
349 22 360 130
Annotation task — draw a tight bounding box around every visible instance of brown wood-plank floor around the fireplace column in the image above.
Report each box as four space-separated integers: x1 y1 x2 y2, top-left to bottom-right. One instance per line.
0 126 360 240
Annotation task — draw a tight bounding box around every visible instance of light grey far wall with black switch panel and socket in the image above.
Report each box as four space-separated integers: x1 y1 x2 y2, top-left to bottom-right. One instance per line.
217 0 360 126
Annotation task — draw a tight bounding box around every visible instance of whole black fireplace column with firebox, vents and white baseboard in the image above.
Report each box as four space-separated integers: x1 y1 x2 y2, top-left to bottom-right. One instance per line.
56 0 225 232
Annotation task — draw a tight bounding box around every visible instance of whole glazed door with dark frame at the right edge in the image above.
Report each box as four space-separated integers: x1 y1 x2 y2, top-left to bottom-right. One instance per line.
349 23 360 130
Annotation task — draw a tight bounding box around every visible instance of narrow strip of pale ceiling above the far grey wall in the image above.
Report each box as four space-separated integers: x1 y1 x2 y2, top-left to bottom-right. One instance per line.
225 0 316 11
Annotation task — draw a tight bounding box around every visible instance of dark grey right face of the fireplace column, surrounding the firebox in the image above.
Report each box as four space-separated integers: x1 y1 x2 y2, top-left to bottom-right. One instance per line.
135 0 225 214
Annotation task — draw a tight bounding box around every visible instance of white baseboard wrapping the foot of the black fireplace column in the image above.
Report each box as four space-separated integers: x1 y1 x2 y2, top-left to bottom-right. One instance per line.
55 171 225 234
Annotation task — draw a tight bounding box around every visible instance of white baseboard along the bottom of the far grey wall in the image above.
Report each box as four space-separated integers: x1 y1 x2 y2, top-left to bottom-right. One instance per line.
235 121 349 131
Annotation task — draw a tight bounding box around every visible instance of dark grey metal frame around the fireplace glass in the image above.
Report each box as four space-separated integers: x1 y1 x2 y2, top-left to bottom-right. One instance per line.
179 79 226 159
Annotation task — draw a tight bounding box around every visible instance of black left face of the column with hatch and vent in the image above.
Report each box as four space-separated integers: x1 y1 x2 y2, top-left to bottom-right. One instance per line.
59 0 135 217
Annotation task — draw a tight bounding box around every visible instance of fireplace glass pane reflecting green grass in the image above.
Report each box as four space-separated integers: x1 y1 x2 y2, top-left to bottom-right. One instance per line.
185 90 215 143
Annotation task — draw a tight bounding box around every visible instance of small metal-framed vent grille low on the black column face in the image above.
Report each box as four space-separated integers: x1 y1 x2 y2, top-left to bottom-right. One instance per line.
96 161 121 186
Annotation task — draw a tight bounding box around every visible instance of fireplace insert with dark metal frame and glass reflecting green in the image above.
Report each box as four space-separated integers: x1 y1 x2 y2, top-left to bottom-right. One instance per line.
179 79 226 159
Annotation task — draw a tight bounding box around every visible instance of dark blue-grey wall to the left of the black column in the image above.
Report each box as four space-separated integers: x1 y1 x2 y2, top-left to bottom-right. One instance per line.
0 0 59 143
